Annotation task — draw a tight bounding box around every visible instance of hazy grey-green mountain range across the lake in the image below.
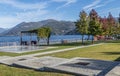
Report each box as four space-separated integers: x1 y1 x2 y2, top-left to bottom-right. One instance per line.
1 19 75 35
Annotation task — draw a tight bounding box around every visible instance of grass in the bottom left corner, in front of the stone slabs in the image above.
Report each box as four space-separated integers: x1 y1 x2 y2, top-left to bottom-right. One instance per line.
0 64 71 76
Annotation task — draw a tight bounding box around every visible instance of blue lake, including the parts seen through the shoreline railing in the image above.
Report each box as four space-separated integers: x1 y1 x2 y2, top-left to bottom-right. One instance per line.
0 35 92 45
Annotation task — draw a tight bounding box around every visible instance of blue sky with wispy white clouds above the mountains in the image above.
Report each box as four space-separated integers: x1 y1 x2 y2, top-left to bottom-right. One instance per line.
0 0 120 28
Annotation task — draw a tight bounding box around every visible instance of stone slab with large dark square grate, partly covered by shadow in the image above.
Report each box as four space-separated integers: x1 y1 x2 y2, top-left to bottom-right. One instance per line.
46 58 115 76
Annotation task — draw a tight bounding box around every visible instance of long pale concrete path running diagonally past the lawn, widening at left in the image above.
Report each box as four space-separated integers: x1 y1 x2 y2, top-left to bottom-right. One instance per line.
0 43 103 65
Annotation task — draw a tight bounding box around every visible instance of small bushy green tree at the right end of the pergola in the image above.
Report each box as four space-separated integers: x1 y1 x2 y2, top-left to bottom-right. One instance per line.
37 27 51 45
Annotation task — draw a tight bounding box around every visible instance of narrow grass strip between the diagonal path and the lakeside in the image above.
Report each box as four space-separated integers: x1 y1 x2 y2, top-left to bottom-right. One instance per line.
0 41 93 56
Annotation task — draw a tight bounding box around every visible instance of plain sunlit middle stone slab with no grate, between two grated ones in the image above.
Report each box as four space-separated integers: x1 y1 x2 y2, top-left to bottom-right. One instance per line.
13 56 68 70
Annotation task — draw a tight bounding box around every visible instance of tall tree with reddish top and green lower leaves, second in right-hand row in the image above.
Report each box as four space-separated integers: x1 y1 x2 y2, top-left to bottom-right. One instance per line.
88 9 102 43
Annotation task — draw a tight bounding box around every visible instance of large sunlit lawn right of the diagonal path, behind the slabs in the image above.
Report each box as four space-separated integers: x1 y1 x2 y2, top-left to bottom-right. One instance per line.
38 43 120 61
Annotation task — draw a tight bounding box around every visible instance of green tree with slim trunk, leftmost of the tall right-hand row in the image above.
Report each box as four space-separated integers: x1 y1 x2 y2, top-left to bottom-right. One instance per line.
76 11 88 44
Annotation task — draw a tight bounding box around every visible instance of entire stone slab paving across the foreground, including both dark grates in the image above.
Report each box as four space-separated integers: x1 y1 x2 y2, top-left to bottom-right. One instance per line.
0 56 120 76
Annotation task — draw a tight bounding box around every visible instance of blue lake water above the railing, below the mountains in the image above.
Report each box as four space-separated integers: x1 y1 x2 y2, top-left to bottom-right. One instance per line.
0 35 92 42
